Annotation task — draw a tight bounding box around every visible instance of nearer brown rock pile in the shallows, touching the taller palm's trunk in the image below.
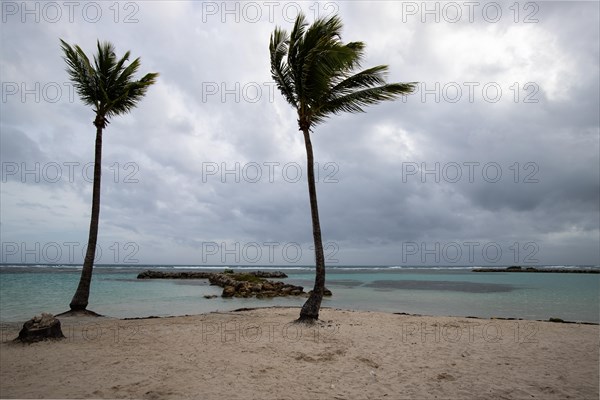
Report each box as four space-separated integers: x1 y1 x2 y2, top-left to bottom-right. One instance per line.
208 273 304 299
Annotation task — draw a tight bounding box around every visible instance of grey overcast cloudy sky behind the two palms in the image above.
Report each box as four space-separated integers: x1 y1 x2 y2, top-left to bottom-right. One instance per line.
0 1 600 266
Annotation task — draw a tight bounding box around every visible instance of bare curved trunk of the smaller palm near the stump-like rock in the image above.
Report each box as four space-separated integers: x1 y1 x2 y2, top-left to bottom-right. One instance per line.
69 120 104 311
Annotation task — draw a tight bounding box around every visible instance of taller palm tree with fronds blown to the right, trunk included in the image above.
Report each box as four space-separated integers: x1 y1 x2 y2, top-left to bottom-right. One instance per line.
269 14 416 322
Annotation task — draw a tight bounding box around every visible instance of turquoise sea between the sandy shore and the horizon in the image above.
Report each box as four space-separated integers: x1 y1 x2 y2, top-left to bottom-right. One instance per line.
0 264 600 323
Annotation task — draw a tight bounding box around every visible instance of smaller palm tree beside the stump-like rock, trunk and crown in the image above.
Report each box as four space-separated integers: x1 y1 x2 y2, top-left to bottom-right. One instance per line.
60 39 158 311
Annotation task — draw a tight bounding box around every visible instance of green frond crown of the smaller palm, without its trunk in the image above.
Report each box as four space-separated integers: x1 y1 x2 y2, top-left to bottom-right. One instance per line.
60 39 158 128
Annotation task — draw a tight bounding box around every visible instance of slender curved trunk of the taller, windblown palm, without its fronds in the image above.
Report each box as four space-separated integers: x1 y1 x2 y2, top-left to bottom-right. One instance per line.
298 128 325 321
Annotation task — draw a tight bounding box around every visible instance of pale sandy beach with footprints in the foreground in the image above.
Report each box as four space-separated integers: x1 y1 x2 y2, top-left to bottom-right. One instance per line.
0 308 599 399
